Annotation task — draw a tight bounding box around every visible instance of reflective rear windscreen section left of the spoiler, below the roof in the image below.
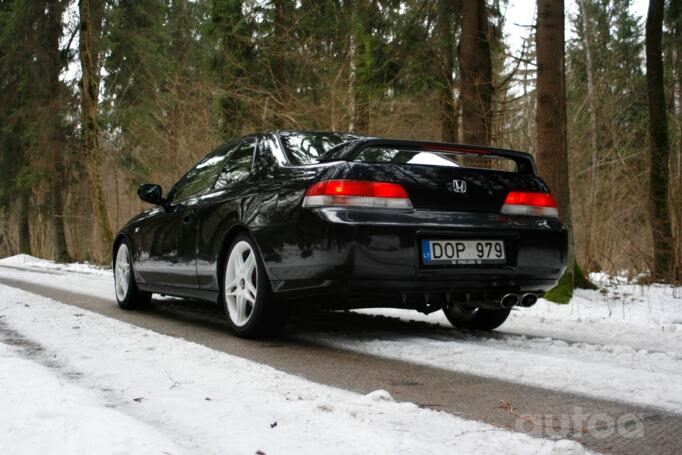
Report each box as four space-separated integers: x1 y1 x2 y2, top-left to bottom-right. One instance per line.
279 133 359 165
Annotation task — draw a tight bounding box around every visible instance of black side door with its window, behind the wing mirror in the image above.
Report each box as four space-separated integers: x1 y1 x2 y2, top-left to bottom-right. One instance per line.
139 144 234 288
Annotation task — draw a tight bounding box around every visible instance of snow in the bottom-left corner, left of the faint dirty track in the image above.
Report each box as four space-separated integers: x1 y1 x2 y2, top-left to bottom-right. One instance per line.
0 343 179 455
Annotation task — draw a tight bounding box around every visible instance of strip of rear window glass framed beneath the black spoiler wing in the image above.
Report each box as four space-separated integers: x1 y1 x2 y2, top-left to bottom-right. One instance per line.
354 147 517 172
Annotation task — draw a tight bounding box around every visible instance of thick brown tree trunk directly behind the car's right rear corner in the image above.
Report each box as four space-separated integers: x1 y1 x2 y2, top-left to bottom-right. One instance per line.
535 0 576 303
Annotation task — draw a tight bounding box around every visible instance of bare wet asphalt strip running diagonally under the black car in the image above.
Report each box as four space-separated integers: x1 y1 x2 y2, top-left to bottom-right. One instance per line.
0 277 682 454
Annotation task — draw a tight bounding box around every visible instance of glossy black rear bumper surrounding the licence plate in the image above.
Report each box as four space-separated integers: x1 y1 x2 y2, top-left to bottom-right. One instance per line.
262 208 567 304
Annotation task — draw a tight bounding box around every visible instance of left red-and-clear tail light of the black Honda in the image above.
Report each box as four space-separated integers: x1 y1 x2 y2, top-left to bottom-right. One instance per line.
303 180 412 209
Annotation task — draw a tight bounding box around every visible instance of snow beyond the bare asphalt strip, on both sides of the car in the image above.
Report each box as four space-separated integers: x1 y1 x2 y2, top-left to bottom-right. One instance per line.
0 258 682 413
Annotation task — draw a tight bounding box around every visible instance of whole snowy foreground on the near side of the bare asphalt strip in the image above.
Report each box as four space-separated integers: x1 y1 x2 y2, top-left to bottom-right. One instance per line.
0 286 572 454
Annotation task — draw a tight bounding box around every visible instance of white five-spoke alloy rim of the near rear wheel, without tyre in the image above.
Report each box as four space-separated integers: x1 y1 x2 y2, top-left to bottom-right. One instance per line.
224 240 258 327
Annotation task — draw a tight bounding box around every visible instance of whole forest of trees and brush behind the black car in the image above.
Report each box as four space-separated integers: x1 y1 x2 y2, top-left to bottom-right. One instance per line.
0 0 682 300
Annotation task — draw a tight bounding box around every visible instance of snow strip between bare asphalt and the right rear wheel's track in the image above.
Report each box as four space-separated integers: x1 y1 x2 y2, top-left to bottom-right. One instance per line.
304 318 682 413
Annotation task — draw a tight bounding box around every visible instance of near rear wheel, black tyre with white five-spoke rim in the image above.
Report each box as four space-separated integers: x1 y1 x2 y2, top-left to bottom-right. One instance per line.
220 234 287 338
